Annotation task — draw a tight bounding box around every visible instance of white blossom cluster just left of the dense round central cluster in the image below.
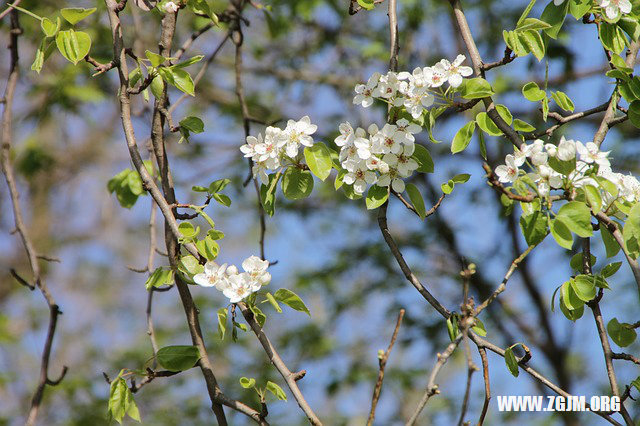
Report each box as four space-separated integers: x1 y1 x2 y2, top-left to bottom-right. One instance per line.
240 115 318 183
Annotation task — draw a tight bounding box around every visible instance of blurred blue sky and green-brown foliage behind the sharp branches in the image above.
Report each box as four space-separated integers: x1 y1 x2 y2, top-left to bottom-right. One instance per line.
0 0 640 425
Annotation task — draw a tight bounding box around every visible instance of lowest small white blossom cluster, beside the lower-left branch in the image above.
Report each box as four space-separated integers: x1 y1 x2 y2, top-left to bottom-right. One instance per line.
193 256 271 303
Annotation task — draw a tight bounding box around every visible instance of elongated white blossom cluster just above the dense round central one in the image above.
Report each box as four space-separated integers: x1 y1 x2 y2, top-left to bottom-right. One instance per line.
353 55 473 119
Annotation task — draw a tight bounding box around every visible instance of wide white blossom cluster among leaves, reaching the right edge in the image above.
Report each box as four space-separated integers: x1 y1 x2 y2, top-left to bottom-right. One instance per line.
495 136 640 209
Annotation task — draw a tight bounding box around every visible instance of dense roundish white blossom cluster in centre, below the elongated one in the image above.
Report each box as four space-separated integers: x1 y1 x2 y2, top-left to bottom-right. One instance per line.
335 118 422 195
